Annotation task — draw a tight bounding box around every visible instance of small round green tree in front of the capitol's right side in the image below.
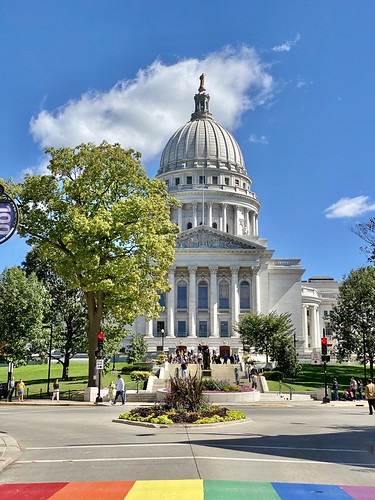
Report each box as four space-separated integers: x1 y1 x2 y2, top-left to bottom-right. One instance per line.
236 311 298 377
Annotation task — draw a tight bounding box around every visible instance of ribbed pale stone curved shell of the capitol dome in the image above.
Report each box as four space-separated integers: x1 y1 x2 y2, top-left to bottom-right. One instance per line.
158 119 246 174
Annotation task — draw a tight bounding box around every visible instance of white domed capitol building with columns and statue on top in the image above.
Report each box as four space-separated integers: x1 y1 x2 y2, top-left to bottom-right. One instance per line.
132 75 339 359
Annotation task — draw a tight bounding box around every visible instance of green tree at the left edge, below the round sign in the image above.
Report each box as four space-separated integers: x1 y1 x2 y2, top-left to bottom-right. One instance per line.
0 267 50 366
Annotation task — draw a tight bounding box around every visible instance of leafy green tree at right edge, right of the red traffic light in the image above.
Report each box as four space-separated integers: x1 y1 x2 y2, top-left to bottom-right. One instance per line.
330 266 375 378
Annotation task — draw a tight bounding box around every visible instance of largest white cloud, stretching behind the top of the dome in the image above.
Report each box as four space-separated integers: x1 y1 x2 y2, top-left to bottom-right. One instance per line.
30 47 275 174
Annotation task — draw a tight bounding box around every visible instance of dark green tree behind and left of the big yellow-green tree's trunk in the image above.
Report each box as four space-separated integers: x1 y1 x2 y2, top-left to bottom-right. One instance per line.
22 249 87 380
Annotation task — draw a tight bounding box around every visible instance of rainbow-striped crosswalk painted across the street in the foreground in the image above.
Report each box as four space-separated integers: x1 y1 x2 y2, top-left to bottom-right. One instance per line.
0 479 375 500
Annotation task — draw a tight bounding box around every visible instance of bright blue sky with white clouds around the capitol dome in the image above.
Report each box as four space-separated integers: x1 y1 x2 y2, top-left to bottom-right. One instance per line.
0 0 375 280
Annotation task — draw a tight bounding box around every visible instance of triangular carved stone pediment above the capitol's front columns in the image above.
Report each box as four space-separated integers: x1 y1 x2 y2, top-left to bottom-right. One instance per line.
176 227 264 250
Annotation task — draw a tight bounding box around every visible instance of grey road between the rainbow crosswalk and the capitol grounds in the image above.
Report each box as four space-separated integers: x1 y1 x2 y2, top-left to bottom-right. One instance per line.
0 402 375 486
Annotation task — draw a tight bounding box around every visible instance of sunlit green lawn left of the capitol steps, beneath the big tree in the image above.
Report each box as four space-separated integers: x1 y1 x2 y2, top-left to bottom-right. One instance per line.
0 362 140 399
